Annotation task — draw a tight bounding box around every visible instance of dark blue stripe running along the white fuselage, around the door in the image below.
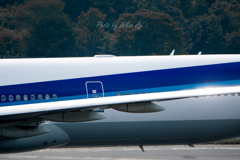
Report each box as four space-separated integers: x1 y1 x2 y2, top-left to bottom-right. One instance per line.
0 62 240 105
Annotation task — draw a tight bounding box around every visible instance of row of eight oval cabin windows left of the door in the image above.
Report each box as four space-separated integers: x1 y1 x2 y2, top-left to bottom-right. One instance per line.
1 94 57 102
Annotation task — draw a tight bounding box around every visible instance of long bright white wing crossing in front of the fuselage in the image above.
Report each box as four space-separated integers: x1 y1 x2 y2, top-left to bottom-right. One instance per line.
0 86 240 120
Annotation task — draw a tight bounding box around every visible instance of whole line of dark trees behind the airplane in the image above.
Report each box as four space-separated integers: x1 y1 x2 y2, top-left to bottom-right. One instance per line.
0 0 240 57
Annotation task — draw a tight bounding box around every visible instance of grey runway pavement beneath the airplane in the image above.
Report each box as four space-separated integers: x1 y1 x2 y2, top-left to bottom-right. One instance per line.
0 145 240 160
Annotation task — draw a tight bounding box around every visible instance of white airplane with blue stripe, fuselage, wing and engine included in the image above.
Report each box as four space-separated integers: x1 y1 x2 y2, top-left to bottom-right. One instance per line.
0 53 240 154
